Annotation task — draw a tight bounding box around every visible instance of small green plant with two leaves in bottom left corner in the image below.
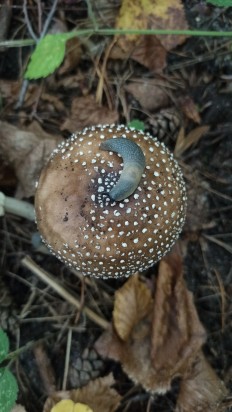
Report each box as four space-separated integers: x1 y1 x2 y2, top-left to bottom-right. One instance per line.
0 329 18 412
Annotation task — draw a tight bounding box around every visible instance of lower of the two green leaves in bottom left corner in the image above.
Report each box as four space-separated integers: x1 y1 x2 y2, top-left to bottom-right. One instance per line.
0 368 18 412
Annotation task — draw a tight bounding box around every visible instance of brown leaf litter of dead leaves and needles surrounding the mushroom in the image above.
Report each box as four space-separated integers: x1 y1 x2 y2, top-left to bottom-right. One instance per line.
0 0 232 412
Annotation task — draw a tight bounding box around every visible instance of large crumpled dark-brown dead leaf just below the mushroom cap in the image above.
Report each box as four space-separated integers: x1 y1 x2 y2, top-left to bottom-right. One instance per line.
95 253 219 394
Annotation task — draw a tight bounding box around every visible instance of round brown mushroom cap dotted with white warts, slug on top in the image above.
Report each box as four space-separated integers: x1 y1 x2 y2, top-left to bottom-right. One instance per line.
35 125 186 278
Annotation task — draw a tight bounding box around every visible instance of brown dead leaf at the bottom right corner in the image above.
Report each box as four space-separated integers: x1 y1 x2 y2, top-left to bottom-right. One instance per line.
175 352 227 412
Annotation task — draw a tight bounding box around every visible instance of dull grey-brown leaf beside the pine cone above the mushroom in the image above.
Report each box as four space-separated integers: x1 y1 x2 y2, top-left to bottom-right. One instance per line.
125 79 169 111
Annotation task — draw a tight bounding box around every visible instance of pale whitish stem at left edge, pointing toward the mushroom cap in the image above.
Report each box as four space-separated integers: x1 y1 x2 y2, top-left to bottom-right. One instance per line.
0 192 35 222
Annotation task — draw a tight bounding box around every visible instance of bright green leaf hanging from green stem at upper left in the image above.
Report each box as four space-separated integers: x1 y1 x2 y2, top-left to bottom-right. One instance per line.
24 33 67 80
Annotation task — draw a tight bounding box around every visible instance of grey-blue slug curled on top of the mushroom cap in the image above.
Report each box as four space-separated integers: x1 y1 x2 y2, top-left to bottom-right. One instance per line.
100 137 146 201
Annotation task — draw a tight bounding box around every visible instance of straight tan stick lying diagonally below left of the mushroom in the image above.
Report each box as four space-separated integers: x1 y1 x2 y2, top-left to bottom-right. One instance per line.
21 256 109 329
